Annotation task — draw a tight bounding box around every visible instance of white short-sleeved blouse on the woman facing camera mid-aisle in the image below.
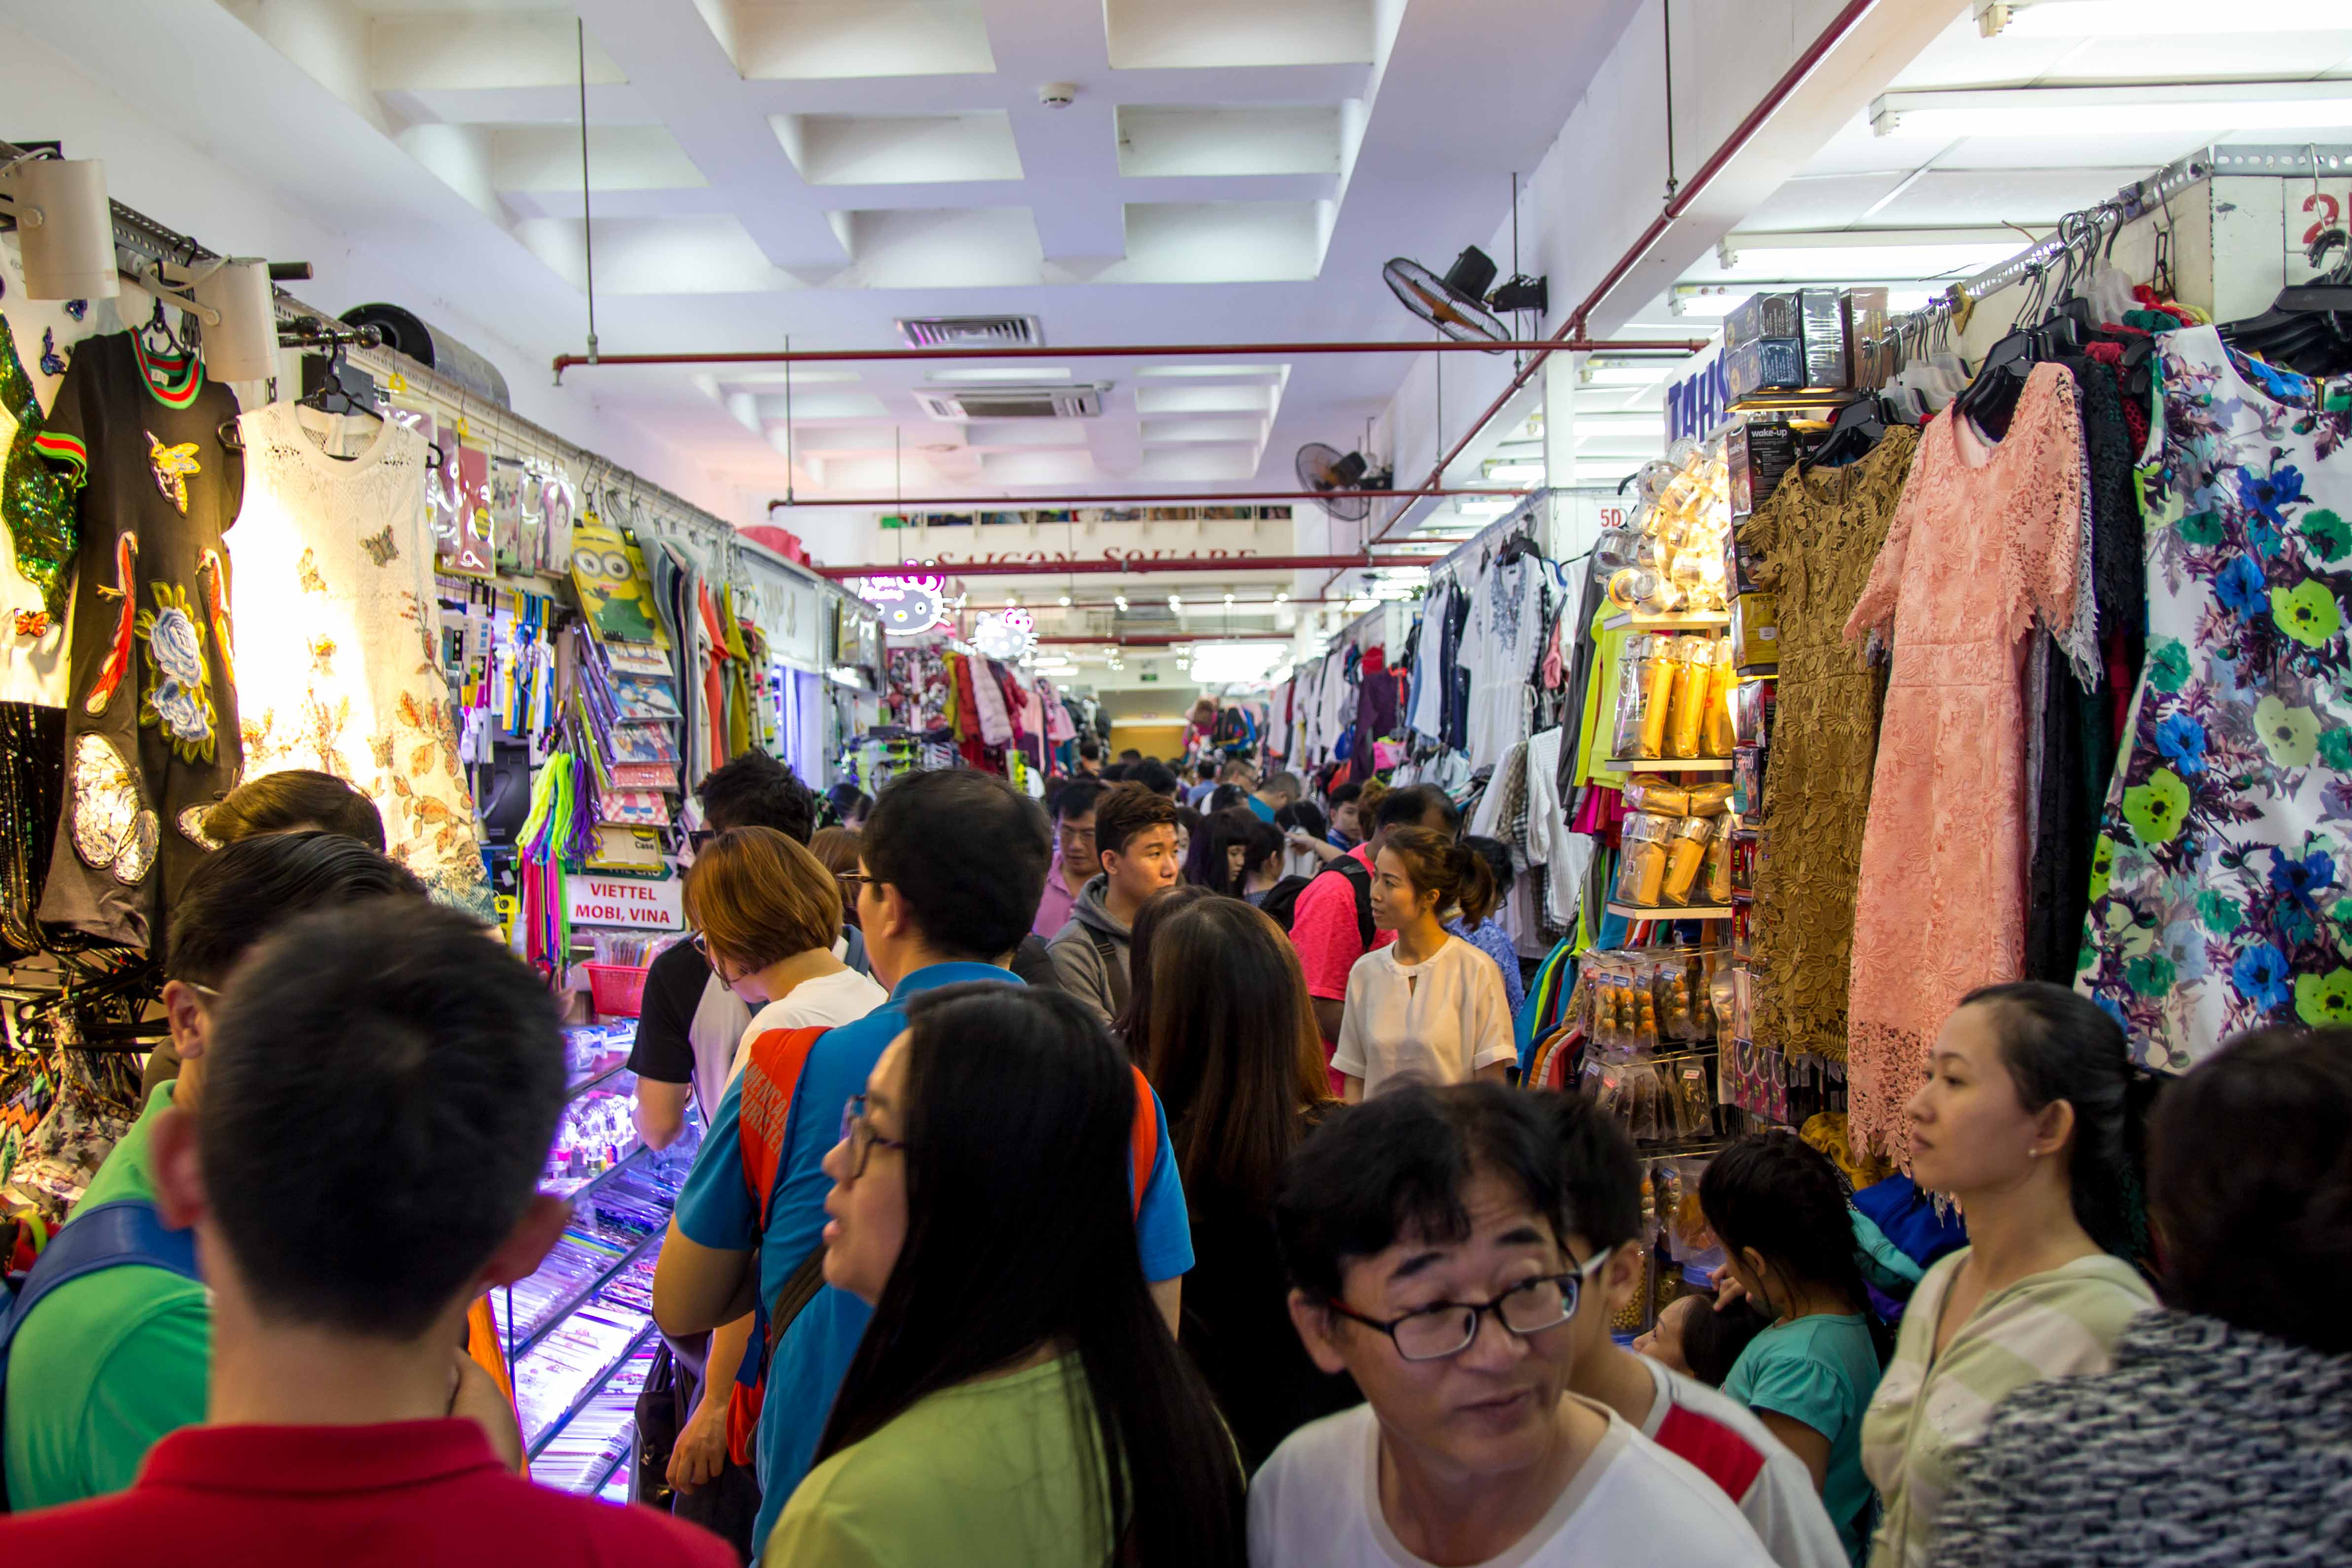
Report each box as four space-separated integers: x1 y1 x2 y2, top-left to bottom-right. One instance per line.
1331 936 1519 1100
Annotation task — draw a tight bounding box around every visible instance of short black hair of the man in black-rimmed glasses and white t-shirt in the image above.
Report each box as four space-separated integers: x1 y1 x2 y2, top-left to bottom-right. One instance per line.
1275 1079 1566 1302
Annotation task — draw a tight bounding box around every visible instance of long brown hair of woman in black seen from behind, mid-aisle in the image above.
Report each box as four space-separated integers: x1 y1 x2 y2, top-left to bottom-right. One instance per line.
1143 898 1331 1208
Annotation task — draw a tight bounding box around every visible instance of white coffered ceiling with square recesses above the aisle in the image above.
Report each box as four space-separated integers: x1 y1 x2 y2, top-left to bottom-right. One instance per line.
170 0 1632 513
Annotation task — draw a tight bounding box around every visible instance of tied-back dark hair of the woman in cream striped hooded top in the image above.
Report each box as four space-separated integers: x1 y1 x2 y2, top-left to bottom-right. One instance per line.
1959 980 2154 1267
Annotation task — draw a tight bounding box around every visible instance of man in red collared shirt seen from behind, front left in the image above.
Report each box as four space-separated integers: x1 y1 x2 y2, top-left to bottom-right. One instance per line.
0 901 736 1568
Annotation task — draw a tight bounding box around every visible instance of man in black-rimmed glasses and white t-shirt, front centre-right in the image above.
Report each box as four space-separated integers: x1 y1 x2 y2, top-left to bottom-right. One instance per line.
1249 1084 1771 1568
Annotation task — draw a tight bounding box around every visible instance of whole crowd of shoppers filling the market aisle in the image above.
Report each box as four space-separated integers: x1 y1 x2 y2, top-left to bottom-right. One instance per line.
0 757 2352 1568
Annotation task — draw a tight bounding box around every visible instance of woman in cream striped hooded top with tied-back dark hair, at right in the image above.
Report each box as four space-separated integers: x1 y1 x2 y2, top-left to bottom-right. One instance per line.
1863 980 2154 1568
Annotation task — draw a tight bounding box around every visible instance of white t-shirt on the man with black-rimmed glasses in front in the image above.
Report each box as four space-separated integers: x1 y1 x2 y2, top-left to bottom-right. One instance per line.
1249 1394 1771 1568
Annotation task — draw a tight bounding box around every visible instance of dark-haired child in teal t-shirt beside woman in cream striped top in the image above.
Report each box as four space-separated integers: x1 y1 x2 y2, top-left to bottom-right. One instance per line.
1698 1133 1879 1563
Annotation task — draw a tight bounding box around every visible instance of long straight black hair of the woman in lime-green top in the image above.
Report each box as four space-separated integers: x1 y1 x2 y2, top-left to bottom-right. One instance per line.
816 982 1247 1568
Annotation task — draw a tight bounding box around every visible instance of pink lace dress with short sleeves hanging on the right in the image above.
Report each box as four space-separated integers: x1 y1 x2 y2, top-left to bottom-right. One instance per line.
1846 364 2084 1159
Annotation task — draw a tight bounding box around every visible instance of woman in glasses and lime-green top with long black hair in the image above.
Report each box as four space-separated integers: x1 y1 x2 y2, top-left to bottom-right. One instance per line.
762 985 1242 1568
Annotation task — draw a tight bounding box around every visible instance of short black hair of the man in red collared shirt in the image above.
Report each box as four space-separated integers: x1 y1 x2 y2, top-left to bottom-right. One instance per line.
195 901 564 1340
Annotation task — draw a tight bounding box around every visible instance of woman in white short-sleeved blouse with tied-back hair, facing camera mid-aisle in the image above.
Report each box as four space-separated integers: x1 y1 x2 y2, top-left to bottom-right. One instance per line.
1331 828 1519 1103
